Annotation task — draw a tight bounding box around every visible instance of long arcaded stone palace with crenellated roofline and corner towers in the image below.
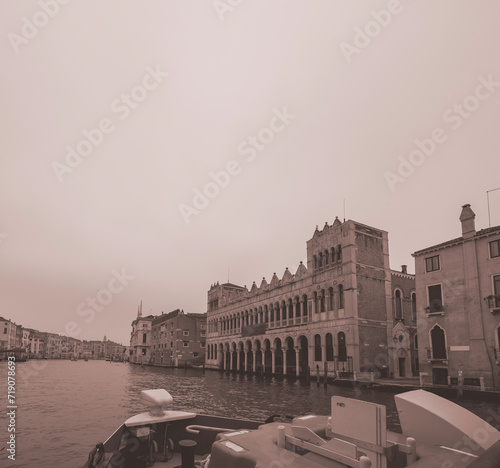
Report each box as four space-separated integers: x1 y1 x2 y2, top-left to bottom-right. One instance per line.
206 219 411 378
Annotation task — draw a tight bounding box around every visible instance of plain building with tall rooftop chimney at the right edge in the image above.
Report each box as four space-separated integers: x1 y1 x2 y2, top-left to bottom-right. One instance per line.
413 205 500 388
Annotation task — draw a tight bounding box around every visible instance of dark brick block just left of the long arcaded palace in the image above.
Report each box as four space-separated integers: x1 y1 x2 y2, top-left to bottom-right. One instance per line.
150 309 207 367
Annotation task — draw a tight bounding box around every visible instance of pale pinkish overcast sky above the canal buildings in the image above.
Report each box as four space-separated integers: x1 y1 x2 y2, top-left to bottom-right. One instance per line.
0 0 500 344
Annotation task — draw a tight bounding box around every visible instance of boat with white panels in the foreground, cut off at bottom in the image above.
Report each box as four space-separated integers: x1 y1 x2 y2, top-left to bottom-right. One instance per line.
84 389 500 468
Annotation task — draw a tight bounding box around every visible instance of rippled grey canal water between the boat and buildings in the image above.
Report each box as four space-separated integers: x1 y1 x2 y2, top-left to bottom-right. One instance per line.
0 361 500 468
